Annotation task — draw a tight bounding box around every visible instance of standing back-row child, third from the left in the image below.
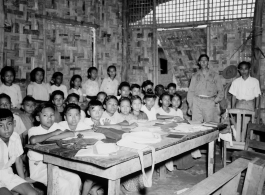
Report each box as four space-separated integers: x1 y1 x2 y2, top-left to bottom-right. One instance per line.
50 72 68 97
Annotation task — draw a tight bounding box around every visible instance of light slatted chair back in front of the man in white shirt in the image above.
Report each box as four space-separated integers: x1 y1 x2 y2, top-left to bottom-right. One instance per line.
228 109 255 142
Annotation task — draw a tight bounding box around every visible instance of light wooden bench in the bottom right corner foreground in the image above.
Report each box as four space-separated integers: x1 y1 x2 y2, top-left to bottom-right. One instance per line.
181 158 265 195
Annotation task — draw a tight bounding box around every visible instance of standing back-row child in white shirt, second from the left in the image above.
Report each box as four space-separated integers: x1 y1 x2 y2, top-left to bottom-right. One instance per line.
27 67 51 102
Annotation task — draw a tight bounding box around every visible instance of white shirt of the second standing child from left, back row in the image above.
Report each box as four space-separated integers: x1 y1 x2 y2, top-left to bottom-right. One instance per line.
27 82 51 101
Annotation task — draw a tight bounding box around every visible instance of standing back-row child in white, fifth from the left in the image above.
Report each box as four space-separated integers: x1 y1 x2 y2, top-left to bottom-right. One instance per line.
82 67 100 101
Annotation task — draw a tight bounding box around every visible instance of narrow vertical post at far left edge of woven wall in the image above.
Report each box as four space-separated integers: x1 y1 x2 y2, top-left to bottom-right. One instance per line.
0 0 5 69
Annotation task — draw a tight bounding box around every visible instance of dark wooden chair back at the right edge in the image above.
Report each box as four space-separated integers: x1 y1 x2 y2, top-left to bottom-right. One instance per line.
245 123 265 153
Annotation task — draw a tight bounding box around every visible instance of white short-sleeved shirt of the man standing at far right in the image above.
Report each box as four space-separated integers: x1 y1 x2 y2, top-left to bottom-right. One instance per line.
229 76 261 101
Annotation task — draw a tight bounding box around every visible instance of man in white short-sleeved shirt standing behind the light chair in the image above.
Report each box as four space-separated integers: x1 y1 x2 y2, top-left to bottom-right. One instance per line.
229 61 261 111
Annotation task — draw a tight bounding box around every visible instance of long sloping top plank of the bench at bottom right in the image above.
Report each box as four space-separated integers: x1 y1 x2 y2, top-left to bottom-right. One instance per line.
181 158 249 195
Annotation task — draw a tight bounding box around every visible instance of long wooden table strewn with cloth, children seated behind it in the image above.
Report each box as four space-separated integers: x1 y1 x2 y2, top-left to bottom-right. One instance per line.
27 129 219 195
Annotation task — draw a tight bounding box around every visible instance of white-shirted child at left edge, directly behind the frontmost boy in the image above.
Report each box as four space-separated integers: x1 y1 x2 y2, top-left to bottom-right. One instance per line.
0 93 27 138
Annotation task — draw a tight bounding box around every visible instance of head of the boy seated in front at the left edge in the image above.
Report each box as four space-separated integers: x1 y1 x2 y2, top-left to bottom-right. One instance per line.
0 109 15 143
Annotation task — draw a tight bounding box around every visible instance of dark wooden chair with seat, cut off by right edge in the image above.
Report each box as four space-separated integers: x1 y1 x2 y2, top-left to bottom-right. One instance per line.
232 123 265 160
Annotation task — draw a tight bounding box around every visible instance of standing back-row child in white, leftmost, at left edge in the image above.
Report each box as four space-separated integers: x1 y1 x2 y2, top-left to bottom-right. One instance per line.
0 66 22 109
